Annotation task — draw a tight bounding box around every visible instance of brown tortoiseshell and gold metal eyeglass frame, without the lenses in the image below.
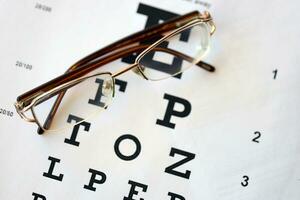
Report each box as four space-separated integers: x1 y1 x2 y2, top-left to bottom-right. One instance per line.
15 11 215 134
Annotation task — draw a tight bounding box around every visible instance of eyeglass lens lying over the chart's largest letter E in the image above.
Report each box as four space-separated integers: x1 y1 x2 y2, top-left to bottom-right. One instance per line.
139 23 210 80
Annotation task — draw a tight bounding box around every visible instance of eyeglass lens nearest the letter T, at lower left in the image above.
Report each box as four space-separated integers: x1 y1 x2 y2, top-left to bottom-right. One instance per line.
33 74 114 130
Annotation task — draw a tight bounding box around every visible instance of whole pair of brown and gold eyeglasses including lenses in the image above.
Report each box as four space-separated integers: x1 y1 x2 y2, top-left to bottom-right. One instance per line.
15 11 215 134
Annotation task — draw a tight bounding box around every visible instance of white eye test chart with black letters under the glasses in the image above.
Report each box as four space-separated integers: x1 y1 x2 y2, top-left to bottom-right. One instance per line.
0 0 300 200
